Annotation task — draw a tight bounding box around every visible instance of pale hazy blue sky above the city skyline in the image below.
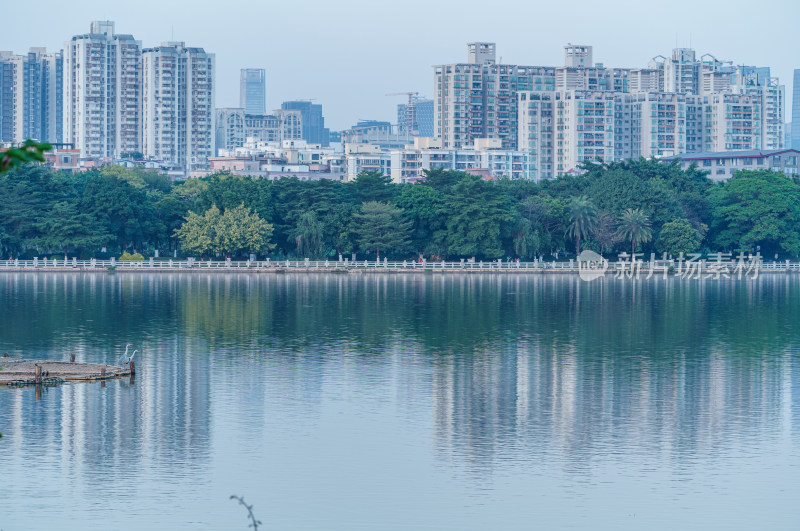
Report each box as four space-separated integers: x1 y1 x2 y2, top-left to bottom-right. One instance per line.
6 0 800 130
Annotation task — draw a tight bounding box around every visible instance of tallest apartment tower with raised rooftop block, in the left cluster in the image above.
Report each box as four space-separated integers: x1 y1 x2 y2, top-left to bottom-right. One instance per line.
63 21 142 158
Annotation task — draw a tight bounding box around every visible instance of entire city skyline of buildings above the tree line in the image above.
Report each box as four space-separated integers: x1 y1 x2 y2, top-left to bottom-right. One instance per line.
0 26 800 182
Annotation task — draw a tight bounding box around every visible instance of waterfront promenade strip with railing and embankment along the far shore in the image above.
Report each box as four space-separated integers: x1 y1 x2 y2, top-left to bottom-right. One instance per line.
0 258 800 277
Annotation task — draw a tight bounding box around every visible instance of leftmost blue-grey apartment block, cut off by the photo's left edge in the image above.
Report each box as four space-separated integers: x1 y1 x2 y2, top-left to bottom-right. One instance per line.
0 48 63 143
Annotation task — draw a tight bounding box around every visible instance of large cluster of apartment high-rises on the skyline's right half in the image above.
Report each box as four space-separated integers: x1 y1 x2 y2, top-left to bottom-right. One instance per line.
434 42 784 179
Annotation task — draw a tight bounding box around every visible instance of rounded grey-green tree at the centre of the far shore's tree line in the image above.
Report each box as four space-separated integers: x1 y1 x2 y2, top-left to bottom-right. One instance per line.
353 201 411 260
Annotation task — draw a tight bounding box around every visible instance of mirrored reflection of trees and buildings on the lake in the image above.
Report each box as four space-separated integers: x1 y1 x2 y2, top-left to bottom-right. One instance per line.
0 274 800 528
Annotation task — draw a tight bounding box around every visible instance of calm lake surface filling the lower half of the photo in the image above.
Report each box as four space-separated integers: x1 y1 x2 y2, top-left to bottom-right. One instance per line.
0 273 800 531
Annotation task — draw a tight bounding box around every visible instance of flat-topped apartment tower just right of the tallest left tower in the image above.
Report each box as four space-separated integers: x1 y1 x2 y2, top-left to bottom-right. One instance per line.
142 42 216 172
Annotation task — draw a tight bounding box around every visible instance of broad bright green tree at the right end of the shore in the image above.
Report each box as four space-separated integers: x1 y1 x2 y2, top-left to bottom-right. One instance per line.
711 170 800 256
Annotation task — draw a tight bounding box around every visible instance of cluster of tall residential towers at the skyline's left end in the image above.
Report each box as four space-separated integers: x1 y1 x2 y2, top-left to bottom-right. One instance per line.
0 21 215 173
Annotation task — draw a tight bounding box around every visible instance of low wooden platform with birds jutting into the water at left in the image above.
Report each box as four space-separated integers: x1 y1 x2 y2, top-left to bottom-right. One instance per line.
0 358 131 385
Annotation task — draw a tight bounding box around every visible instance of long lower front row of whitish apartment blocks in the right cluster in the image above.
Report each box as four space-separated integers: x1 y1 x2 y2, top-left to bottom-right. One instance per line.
519 90 762 180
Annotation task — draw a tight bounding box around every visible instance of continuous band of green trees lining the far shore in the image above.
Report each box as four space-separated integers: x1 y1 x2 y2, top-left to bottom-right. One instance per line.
0 159 800 260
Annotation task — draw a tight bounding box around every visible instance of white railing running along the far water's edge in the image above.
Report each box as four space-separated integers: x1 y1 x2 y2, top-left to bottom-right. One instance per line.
0 258 800 274
